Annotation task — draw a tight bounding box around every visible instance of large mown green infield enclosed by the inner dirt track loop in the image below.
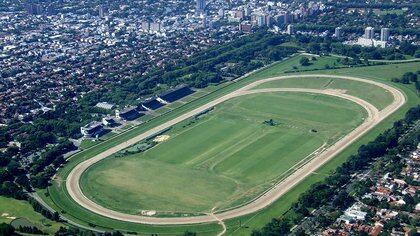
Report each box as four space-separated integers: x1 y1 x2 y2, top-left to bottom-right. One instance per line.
81 93 366 214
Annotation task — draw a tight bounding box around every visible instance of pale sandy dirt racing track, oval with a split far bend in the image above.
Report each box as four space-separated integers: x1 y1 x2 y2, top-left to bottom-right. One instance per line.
66 74 406 225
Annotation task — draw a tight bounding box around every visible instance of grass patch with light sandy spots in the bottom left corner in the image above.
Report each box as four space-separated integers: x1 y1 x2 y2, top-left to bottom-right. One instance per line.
0 196 64 234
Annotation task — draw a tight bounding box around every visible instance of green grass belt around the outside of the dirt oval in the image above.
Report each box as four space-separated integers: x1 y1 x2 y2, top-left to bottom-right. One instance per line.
39 56 420 235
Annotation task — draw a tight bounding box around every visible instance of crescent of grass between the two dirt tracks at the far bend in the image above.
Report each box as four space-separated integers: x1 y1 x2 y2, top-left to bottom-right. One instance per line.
256 78 393 110
